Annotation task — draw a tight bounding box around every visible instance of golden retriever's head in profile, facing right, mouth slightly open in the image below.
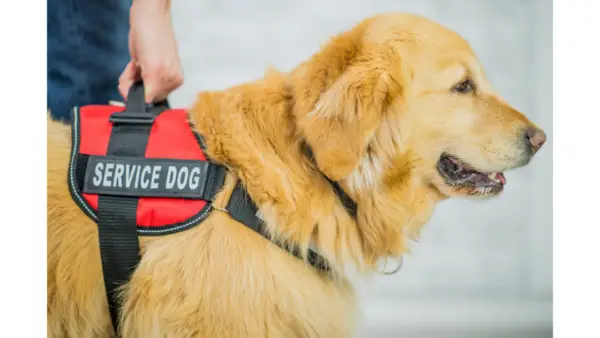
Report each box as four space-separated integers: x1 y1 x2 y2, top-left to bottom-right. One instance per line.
292 14 546 262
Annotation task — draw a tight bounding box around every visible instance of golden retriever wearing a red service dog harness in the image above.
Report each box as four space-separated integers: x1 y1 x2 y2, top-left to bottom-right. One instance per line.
47 13 546 338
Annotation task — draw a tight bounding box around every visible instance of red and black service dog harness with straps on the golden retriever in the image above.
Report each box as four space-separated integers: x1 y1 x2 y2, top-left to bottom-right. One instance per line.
68 83 356 332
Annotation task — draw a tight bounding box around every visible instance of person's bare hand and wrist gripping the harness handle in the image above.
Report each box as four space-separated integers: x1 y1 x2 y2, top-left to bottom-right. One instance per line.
119 0 183 103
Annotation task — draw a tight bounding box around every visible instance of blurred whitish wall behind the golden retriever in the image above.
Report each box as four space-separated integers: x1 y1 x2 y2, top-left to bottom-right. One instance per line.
166 0 552 337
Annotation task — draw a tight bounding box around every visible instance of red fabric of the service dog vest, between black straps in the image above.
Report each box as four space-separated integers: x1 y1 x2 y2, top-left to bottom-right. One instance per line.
69 105 217 235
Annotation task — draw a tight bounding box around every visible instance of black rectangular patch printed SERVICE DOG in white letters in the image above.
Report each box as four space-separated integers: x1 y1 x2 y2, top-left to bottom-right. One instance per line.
83 156 209 199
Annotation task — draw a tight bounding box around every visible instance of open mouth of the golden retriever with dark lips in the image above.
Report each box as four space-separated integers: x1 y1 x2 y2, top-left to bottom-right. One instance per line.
438 154 506 193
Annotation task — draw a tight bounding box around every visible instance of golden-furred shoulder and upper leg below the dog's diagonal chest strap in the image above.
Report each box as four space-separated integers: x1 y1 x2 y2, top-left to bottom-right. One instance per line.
122 211 355 338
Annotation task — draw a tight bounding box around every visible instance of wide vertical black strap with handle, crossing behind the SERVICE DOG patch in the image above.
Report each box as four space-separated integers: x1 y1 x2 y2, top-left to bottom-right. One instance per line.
98 83 166 334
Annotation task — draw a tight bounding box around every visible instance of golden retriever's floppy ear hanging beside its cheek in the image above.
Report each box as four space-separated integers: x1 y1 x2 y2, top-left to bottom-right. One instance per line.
299 64 390 181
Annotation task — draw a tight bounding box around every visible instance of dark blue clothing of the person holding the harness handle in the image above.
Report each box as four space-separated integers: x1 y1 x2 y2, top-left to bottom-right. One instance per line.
47 0 132 122
